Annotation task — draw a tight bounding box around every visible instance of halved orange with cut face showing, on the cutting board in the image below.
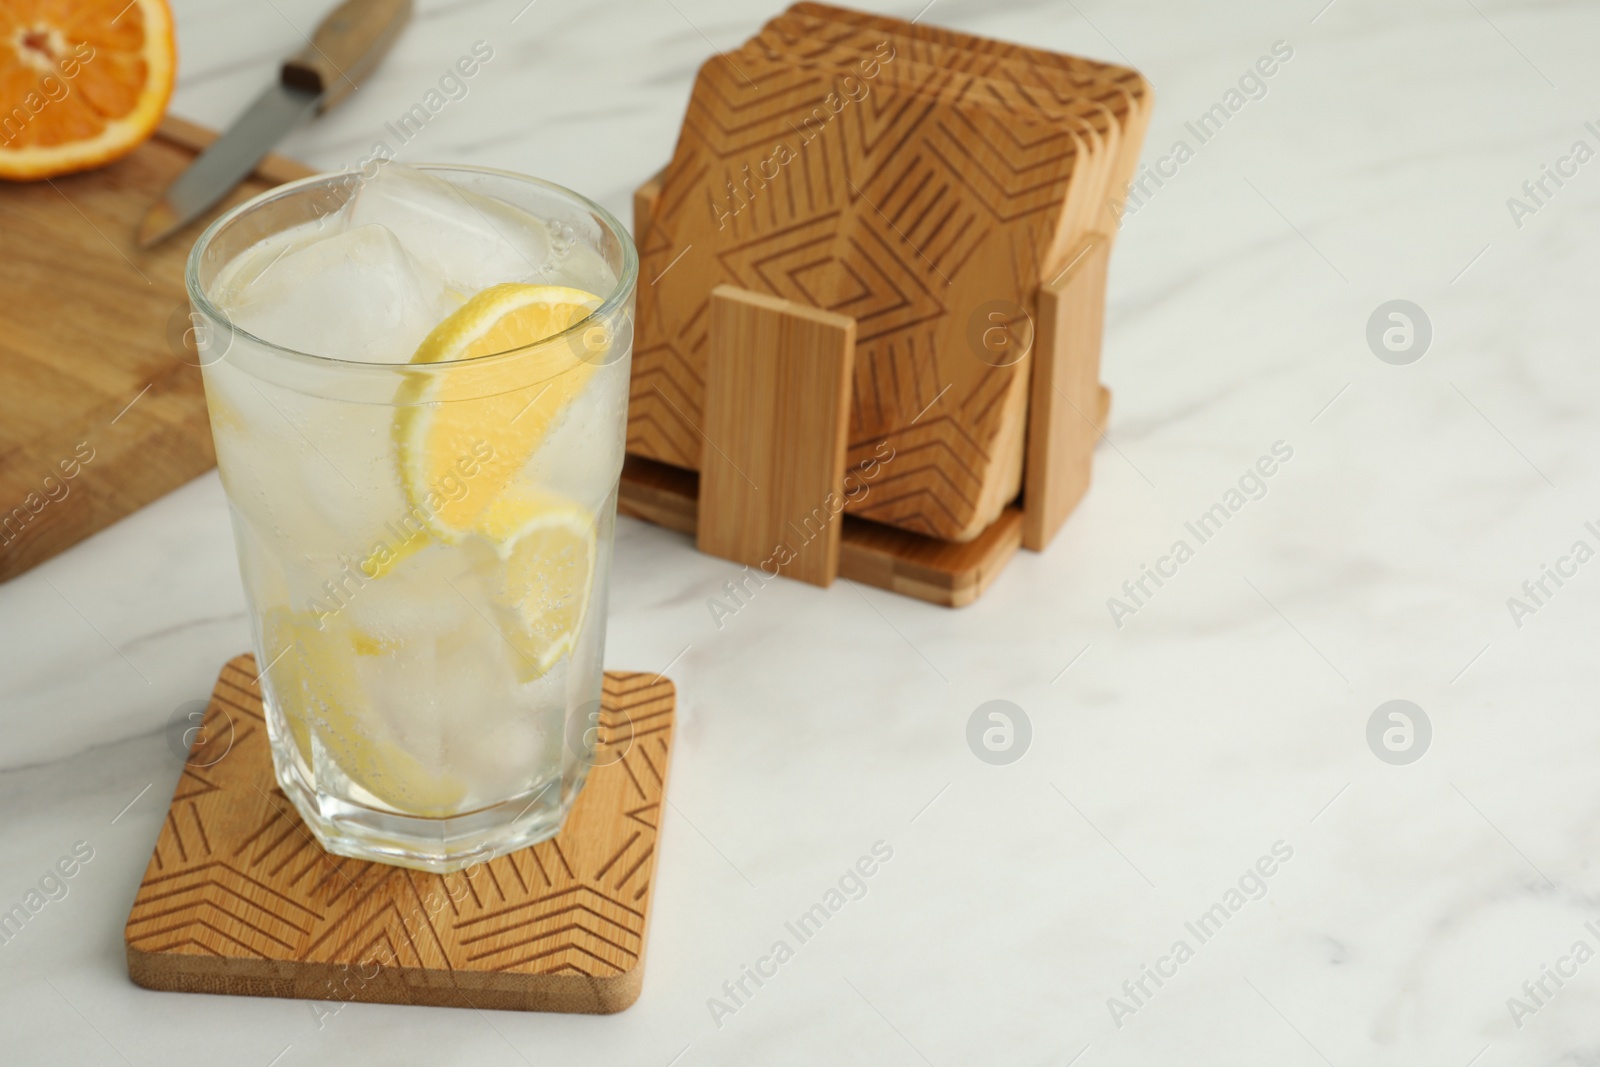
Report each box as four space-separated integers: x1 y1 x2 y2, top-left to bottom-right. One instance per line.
0 0 178 181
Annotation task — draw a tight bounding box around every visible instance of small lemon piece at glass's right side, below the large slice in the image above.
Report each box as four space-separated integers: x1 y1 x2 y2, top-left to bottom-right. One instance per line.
478 490 597 681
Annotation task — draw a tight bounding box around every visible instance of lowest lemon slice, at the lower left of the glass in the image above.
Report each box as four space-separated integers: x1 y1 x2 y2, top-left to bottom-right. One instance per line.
261 608 467 816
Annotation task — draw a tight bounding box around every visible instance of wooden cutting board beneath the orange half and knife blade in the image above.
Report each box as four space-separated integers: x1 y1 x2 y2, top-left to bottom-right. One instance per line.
0 117 312 581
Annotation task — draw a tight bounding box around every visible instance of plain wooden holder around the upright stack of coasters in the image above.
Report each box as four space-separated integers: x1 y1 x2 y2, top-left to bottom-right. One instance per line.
618 173 1110 608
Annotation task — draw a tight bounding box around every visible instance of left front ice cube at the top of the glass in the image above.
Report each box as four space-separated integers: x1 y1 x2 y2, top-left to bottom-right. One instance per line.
219 224 454 363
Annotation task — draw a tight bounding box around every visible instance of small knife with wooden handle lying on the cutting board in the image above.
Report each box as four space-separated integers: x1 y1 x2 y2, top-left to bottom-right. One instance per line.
138 0 411 248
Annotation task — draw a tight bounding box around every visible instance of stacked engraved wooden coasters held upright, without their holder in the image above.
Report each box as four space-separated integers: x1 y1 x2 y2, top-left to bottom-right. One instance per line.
627 3 1150 541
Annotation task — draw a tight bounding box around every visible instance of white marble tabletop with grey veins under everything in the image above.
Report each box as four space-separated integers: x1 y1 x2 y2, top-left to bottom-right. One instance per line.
0 0 1600 1067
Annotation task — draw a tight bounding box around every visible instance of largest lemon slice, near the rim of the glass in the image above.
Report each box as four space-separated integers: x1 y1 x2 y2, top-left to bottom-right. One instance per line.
394 282 605 544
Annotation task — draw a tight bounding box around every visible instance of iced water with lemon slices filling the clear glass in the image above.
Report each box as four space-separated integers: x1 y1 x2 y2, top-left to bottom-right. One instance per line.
203 163 632 851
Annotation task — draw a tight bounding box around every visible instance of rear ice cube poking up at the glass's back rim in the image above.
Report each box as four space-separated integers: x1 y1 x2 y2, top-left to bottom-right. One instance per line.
349 163 550 294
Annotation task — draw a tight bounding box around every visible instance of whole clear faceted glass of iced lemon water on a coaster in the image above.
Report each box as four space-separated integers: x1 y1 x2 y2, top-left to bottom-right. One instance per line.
187 163 638 872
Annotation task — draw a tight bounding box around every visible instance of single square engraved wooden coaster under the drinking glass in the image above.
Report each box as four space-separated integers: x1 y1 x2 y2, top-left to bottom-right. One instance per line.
125 654 675 1013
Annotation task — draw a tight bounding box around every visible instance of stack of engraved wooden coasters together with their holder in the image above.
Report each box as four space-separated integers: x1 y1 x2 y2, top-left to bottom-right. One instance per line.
624 3 1152 601
